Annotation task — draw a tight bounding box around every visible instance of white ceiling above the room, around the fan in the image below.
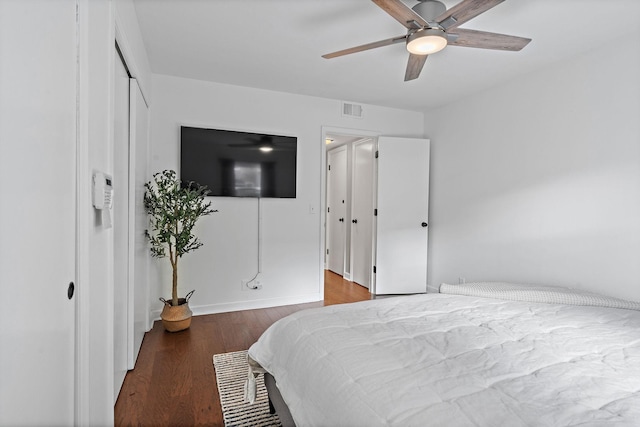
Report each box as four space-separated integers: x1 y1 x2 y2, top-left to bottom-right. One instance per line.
134 0 640 111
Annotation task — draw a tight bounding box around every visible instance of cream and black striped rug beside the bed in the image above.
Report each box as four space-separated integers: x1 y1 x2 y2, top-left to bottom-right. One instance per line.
213 350 281 427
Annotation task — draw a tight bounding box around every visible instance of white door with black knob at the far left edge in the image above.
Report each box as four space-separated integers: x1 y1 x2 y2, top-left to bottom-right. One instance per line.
0 0 75 426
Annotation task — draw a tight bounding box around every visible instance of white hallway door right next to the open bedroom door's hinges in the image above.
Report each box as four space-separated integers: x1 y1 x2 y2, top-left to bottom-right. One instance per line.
350 139 375 288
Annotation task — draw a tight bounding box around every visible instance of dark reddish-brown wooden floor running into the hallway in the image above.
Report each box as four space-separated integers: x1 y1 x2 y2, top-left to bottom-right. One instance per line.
115 271 370 426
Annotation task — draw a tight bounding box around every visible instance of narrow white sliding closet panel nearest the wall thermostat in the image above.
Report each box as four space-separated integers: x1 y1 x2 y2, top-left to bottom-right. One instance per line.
113 48 130 403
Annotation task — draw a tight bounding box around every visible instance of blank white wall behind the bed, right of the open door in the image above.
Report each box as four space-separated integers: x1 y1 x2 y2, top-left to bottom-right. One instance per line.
425 32 640 300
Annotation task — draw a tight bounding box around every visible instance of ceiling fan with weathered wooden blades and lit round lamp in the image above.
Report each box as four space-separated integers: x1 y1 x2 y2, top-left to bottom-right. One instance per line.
322 0 531 81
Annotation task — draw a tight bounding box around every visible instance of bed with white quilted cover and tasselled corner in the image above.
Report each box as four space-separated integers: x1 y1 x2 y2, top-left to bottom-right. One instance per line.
247 283 640 427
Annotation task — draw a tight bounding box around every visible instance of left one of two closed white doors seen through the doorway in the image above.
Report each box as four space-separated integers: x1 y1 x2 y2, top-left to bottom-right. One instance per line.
327 146 347 276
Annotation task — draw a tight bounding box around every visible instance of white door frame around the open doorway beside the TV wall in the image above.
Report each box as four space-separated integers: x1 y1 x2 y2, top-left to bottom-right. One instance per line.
318 126 381 295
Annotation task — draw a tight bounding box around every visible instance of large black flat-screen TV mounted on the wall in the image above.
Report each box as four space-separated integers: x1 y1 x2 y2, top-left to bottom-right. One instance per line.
180 126 298 198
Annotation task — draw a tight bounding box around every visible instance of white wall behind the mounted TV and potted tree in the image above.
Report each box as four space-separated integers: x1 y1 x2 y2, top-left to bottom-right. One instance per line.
150 75 423 314
